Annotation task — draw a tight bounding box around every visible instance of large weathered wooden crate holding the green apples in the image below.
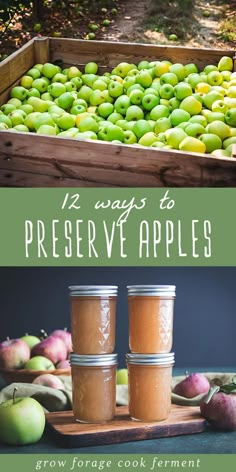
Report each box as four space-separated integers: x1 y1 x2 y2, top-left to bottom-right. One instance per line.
0 38 236 187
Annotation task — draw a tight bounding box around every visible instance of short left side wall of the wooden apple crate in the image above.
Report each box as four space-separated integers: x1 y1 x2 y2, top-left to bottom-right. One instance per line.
0 39 35 95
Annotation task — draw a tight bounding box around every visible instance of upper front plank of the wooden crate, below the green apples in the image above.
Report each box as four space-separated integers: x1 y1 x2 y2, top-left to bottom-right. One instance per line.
0 131 236 187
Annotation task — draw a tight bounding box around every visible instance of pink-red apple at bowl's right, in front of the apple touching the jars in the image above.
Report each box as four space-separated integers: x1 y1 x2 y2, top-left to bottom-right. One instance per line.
31 335 67 364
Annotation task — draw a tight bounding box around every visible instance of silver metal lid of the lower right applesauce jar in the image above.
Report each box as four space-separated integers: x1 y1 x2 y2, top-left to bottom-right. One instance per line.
126 352 175 367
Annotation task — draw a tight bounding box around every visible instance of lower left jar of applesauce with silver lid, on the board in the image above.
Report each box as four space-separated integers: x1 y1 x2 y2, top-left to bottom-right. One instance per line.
70 353 117 423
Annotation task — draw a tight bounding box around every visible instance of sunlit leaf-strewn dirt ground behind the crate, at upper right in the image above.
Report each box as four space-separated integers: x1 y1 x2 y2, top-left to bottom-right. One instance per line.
104 0 236 48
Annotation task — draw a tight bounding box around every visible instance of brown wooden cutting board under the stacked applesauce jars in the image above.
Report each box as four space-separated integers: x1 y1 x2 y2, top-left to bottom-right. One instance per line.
46 405 206 447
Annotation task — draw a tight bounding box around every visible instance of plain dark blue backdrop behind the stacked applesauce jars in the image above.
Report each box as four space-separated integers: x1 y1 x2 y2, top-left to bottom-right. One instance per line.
0 267 236 368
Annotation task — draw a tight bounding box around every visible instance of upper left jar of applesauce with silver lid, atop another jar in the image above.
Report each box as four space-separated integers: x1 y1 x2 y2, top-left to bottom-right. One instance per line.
69 285 118 354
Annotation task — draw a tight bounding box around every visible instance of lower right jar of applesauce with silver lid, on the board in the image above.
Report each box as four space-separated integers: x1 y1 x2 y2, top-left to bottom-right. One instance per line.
126 353 174 421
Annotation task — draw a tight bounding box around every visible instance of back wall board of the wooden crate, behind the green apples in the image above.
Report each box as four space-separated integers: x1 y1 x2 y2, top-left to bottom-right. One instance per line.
50 38 235 68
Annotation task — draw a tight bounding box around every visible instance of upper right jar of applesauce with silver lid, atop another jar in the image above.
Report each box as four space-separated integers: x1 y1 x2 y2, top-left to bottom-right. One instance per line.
127 285 175 354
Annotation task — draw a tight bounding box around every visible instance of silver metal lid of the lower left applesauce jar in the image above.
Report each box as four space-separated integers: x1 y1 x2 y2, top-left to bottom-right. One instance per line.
70 352 118 367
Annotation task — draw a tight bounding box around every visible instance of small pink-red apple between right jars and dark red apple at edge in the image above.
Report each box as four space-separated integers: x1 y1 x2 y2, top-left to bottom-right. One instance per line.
174 373 210 398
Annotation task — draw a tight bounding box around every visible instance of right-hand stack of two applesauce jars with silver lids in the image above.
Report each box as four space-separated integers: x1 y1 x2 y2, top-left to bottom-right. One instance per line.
126 285 175 421
